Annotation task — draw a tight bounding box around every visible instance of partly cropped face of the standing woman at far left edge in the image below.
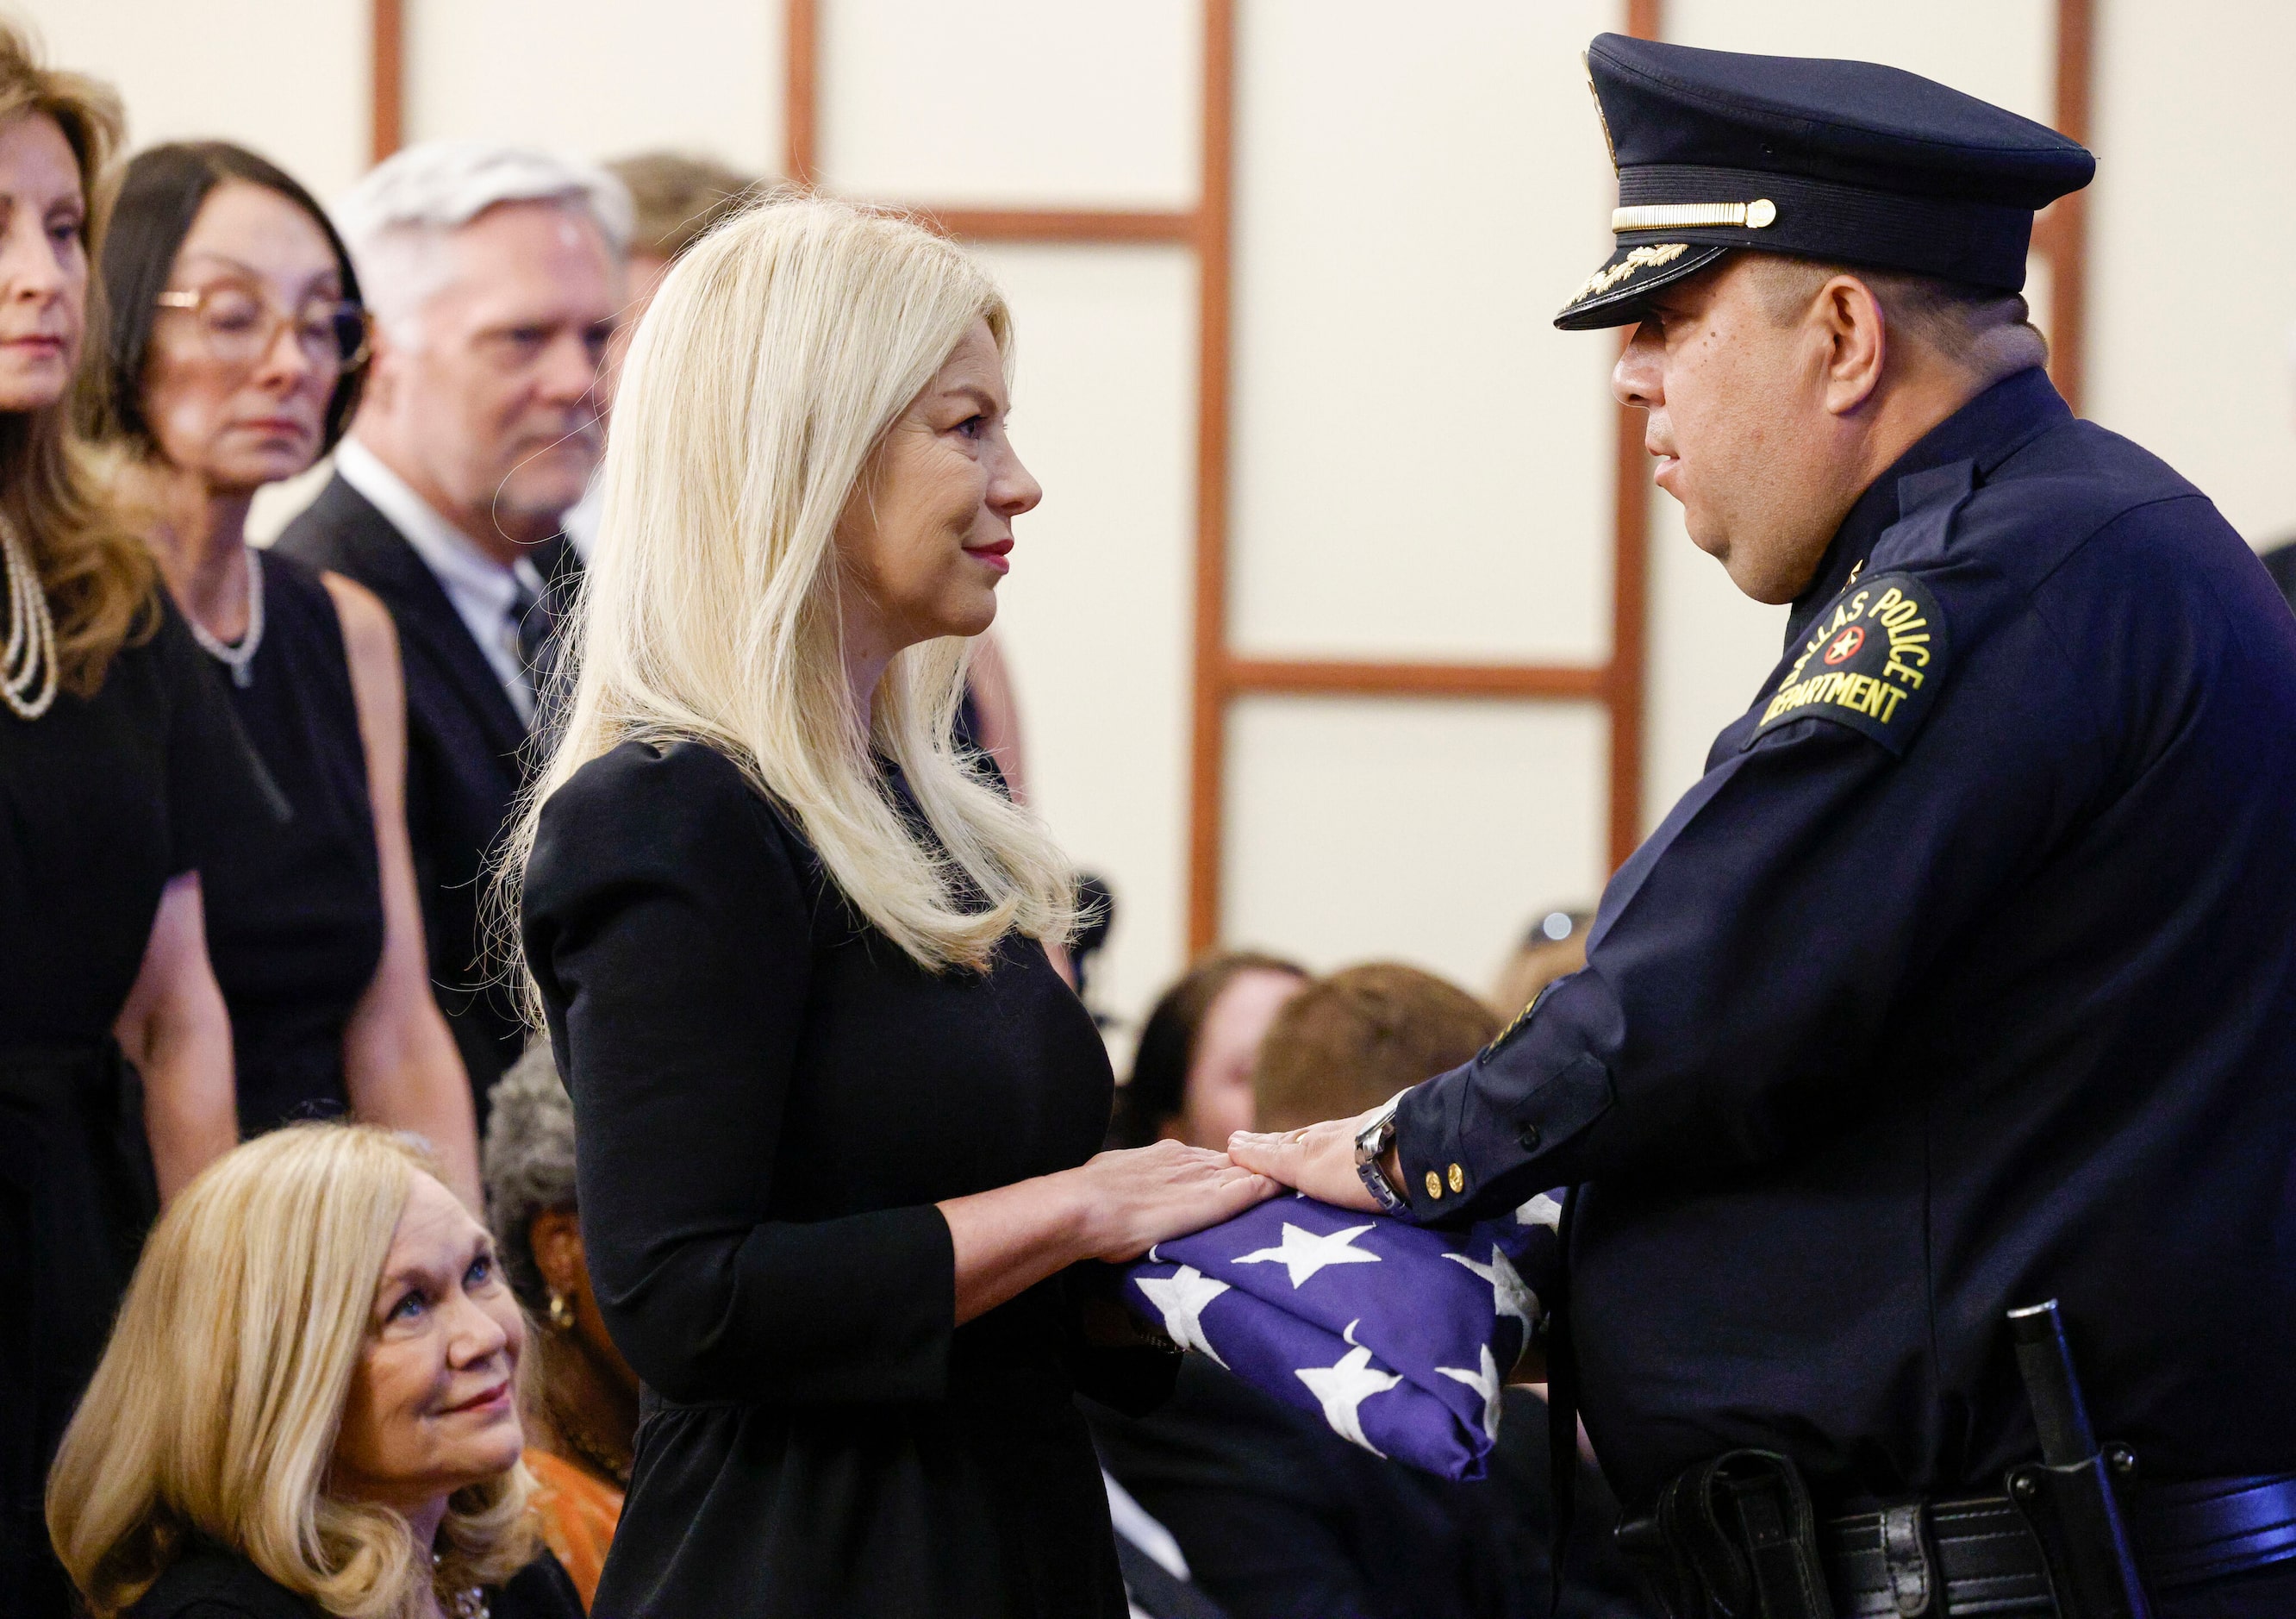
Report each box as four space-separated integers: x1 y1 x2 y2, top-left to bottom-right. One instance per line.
0 113 87 411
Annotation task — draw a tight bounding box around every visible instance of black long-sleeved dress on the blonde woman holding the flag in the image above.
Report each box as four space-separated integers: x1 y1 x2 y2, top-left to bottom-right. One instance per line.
523 741 1171 1619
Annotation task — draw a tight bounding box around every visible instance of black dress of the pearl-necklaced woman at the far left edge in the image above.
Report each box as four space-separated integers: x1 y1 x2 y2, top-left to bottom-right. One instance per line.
0 609 269 1619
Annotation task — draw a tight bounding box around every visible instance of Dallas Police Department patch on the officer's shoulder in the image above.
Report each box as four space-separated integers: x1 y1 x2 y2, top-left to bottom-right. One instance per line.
1745 574 1947 753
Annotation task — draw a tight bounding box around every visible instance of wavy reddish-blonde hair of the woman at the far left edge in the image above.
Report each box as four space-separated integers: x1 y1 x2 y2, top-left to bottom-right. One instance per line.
0 21 159 698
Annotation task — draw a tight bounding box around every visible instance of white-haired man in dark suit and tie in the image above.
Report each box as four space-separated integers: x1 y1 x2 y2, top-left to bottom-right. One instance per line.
280 142 629 1125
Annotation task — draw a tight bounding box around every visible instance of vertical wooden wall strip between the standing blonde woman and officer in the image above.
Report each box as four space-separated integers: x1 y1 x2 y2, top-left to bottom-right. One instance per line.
1187 0 1235 955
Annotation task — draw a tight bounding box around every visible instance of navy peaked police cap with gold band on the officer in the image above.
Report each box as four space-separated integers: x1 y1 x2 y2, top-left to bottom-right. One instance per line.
1555 34 2096 331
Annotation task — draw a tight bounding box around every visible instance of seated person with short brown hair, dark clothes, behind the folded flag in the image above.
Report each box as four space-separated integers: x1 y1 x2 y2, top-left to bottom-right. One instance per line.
1089 962 1642 1619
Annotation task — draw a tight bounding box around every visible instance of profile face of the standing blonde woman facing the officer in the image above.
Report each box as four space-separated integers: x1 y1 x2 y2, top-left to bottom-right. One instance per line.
838 322 1045 654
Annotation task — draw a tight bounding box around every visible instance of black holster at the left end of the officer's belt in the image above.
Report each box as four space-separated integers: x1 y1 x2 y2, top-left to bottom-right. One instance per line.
1619 1452 1835 1619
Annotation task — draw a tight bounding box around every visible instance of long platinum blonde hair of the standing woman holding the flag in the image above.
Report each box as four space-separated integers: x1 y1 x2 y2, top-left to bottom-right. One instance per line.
501 197 1075 972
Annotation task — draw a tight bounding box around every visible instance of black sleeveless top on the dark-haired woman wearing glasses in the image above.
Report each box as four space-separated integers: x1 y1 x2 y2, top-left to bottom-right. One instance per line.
202 551 384 1135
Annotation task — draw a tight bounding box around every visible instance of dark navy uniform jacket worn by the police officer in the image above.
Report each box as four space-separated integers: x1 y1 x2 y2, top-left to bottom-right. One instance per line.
1396 370 2296 1509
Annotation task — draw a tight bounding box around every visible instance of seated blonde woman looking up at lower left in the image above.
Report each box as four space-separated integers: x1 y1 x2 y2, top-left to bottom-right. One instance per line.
48 1125 581 1619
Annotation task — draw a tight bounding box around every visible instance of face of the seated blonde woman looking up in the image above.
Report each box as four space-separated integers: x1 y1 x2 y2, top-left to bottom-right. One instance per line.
328 1173 526 1511
